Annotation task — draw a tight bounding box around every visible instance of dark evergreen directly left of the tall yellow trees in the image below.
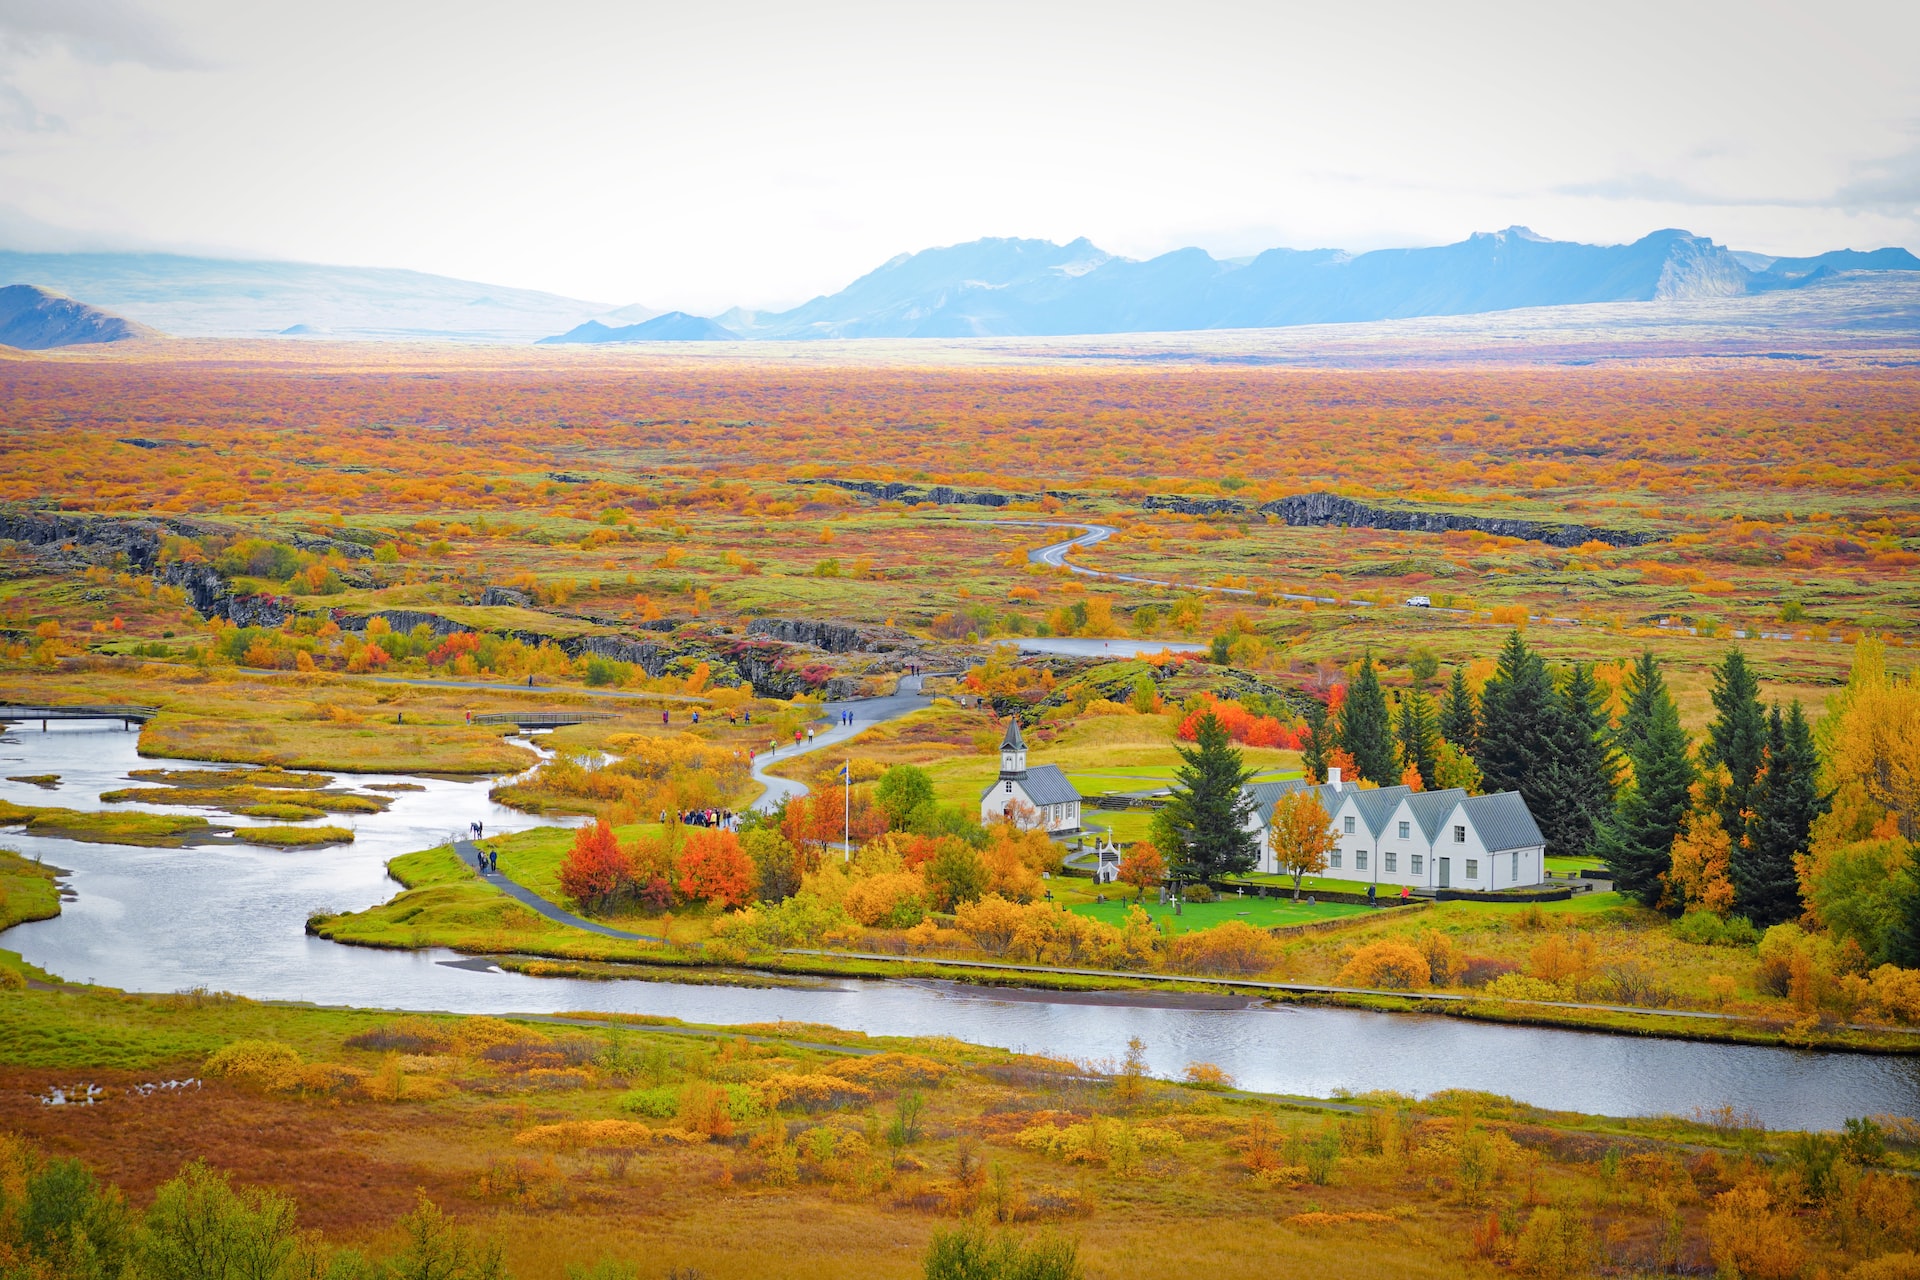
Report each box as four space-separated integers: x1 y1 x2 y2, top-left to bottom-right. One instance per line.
1734 699 1828 925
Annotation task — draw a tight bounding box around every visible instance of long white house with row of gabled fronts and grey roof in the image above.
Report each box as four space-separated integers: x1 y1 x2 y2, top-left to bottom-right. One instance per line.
1244 770 1548 892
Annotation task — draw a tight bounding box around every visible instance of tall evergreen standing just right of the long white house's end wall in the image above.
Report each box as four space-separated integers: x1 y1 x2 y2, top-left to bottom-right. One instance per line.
1597 652 1693 906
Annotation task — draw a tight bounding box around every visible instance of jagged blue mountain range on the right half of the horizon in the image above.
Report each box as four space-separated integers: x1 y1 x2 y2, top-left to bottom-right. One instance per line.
695 226 1920 338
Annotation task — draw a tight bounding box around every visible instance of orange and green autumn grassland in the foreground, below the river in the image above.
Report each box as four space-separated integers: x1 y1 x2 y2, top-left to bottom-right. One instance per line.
0 958 1920 1280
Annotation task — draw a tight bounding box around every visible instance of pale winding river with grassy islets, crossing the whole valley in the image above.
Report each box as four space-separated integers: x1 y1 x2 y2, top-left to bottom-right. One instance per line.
0 725 1920 1128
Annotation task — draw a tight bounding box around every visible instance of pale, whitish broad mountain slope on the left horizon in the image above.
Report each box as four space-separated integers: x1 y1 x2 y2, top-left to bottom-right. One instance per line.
0 251 659 342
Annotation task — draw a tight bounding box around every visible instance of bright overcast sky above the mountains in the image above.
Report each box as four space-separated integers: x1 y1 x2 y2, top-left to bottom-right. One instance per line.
0 0 1920 311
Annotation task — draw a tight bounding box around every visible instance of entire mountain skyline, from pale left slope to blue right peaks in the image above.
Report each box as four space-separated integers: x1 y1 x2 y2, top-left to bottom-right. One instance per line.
0 226 1920 344
